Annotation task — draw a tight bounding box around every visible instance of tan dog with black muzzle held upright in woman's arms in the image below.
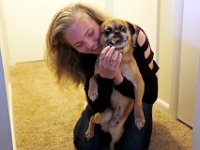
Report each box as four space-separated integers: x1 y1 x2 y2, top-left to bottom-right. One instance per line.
85 19 145 150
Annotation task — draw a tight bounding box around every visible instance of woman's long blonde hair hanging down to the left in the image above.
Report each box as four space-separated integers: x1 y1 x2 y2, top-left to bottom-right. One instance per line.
45 3 107 85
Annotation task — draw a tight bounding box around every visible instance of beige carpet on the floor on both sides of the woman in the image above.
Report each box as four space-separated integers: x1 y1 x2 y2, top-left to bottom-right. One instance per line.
10 61 192 150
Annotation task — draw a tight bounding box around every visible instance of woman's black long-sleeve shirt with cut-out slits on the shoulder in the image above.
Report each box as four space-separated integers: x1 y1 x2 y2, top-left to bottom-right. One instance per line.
81 26 159 112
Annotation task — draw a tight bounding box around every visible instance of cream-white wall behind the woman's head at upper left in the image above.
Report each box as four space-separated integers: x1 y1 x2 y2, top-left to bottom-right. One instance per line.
2 0 105 64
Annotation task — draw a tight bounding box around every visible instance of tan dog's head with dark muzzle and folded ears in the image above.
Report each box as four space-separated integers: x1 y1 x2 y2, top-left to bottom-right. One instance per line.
100 19 135 53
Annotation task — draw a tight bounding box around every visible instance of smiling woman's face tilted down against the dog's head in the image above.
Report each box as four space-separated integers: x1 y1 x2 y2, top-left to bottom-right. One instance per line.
64 15 101 54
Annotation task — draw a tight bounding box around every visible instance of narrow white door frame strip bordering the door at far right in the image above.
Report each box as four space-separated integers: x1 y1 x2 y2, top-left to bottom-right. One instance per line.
169 0 184 118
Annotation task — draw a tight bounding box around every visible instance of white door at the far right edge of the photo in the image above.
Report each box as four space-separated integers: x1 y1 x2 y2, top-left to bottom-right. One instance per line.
178 0 200 127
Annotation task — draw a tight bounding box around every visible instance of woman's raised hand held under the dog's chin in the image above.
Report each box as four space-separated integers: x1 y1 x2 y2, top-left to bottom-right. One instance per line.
99 46 123 84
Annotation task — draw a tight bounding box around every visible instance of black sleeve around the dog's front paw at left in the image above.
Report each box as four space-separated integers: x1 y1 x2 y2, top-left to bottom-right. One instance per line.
85 75 113 112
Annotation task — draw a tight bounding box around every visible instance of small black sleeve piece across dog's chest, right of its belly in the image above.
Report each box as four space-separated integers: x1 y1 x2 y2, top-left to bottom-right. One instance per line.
115 77 135 99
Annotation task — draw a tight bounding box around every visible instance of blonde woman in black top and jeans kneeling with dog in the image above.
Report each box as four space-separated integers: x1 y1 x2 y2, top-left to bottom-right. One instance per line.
46 3 158 150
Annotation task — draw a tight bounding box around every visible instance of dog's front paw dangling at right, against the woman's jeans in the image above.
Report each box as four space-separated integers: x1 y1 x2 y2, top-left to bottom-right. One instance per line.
134 106 145 130
